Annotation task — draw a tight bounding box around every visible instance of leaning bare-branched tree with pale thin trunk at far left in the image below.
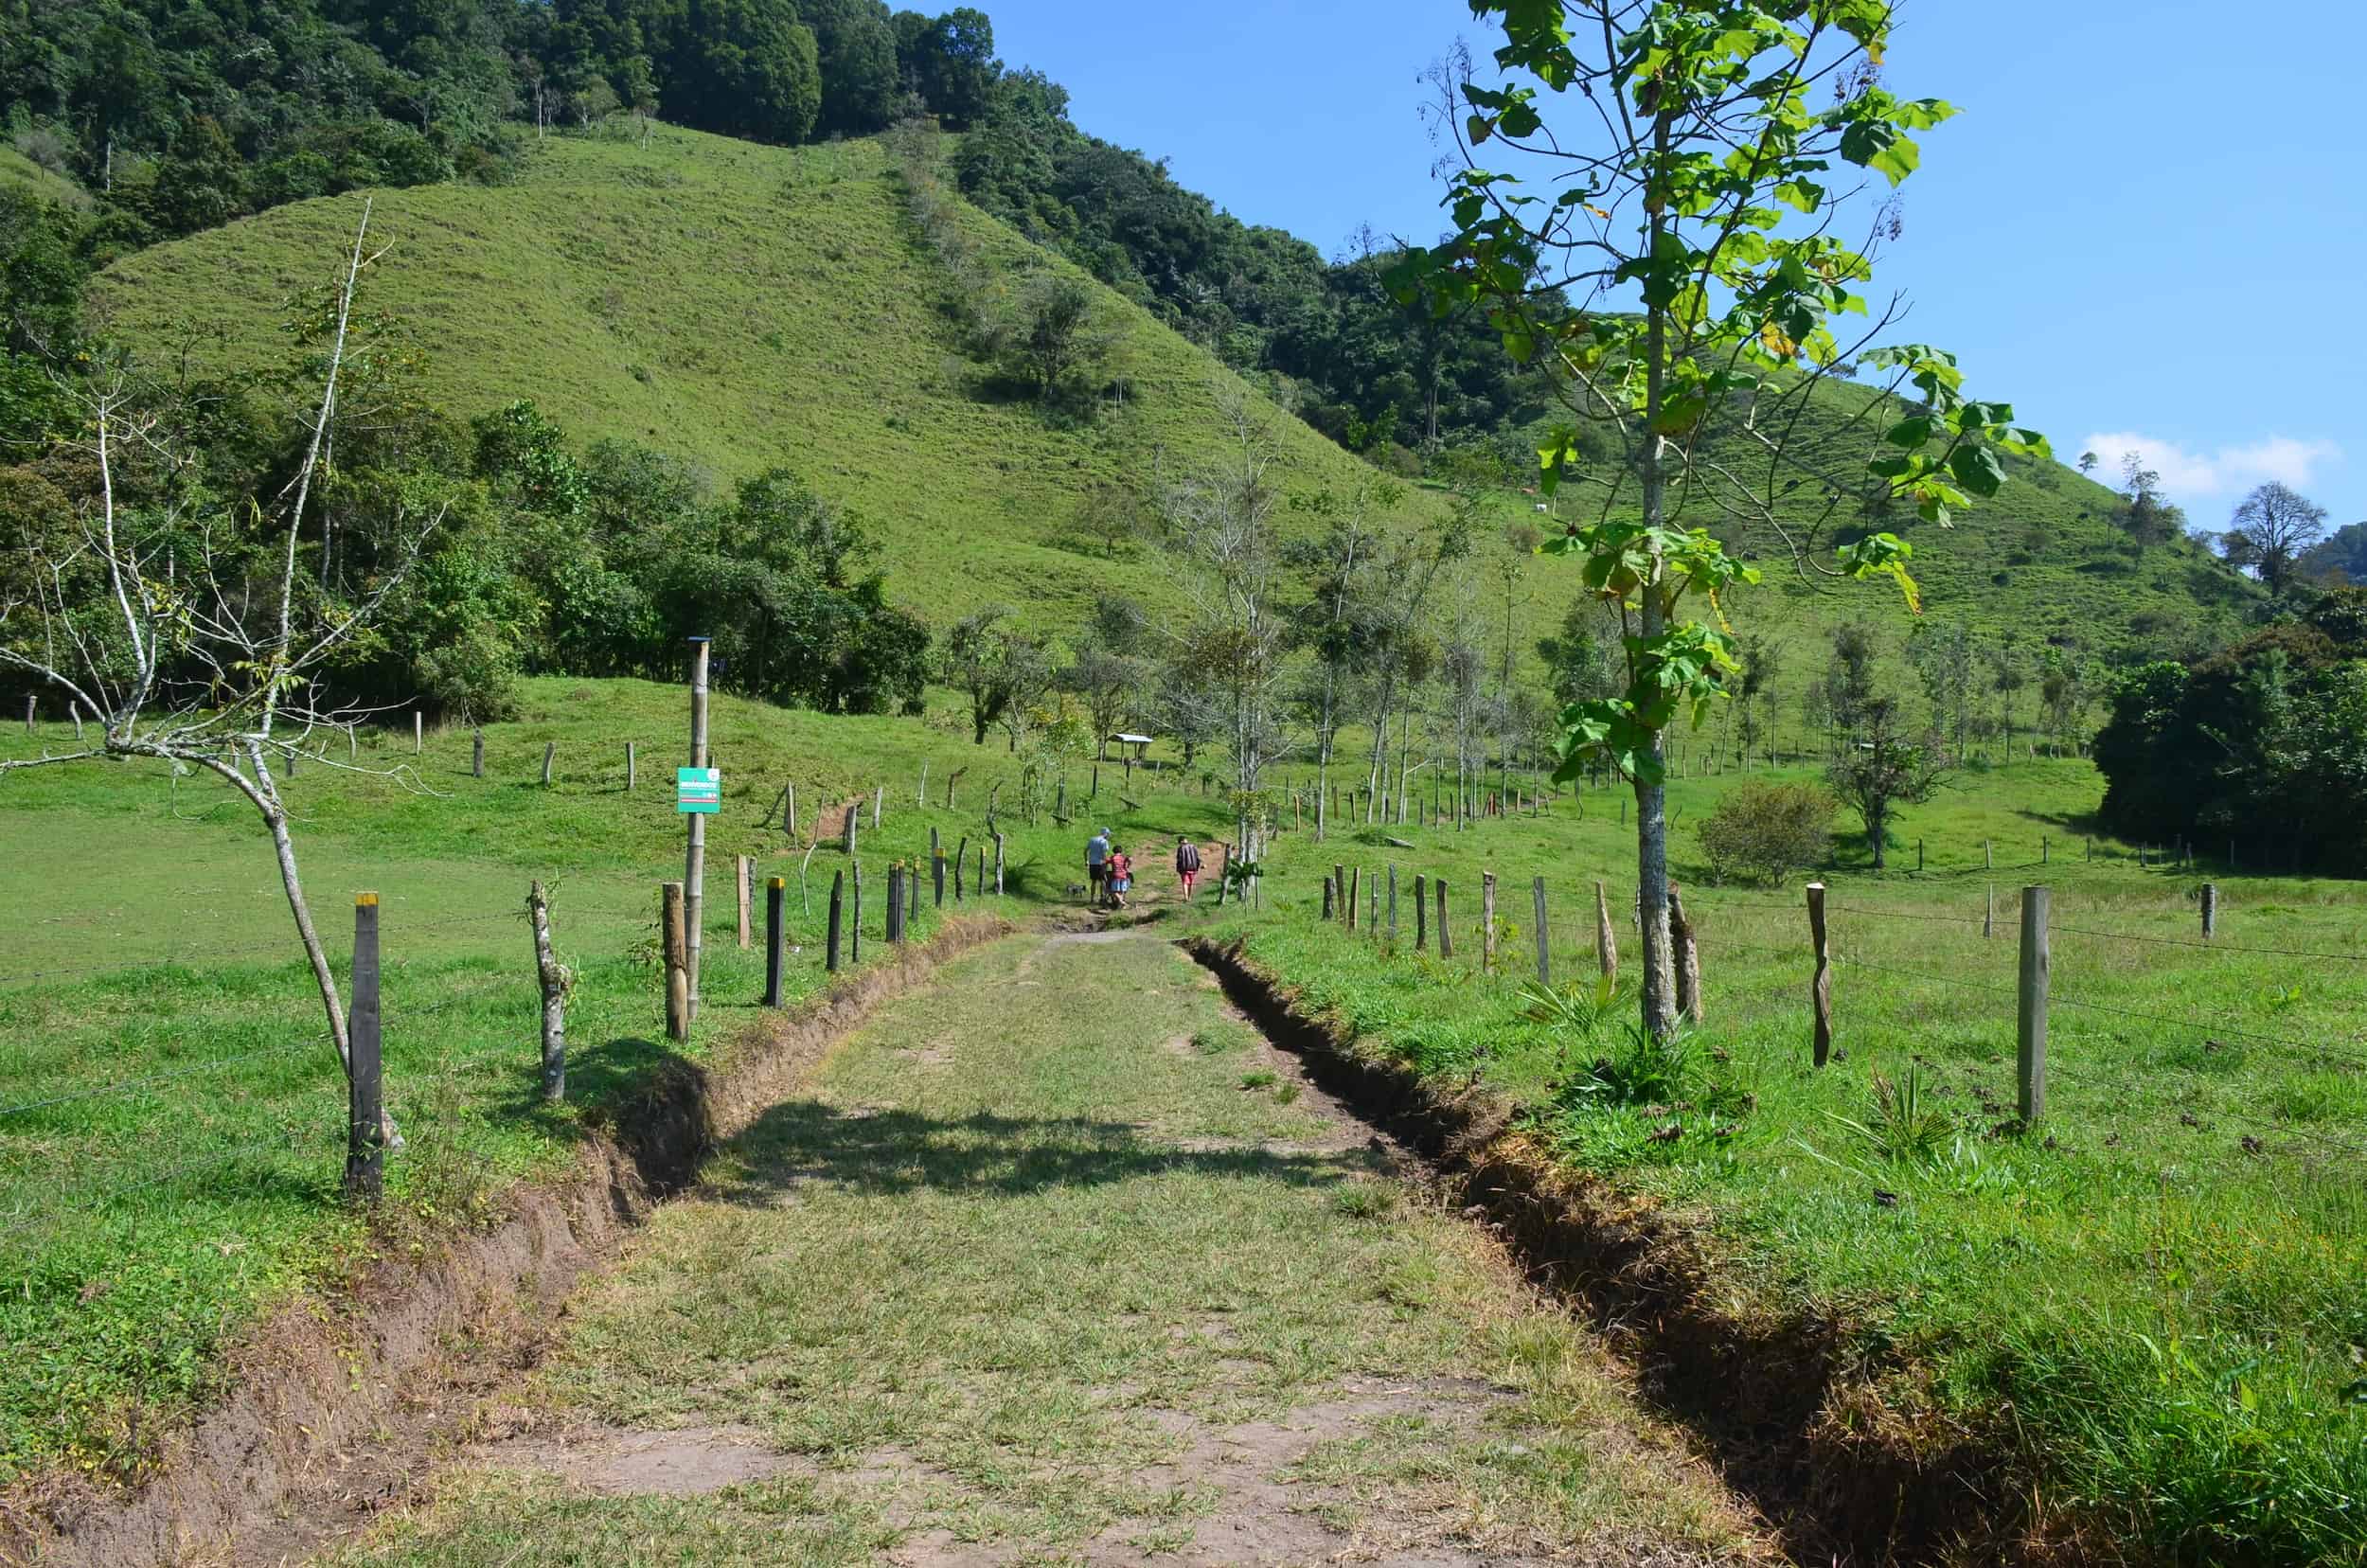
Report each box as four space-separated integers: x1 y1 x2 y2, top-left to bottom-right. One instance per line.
0 204 440 1144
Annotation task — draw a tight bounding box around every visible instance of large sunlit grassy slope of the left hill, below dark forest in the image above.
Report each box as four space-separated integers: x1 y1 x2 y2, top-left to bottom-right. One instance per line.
98 128 1428 625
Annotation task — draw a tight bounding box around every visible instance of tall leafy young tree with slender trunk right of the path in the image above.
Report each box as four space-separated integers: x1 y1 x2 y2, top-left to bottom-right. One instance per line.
1399 0 2045 1038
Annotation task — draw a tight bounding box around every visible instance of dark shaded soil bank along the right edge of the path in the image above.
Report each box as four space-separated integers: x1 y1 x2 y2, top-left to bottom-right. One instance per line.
1186 938 2073 1563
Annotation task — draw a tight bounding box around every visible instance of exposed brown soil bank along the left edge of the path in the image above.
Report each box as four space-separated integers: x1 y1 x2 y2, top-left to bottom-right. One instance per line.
0 919 1011 1568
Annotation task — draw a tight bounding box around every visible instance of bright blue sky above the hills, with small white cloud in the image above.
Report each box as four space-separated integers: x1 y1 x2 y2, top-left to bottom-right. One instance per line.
988 0 2367 528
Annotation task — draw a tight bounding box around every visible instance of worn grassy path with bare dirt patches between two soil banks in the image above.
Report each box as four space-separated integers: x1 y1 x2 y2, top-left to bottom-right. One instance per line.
327 914 1764 1568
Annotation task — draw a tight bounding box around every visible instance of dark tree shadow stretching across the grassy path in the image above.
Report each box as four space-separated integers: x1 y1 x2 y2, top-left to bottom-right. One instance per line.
708 1099 1373 1208
